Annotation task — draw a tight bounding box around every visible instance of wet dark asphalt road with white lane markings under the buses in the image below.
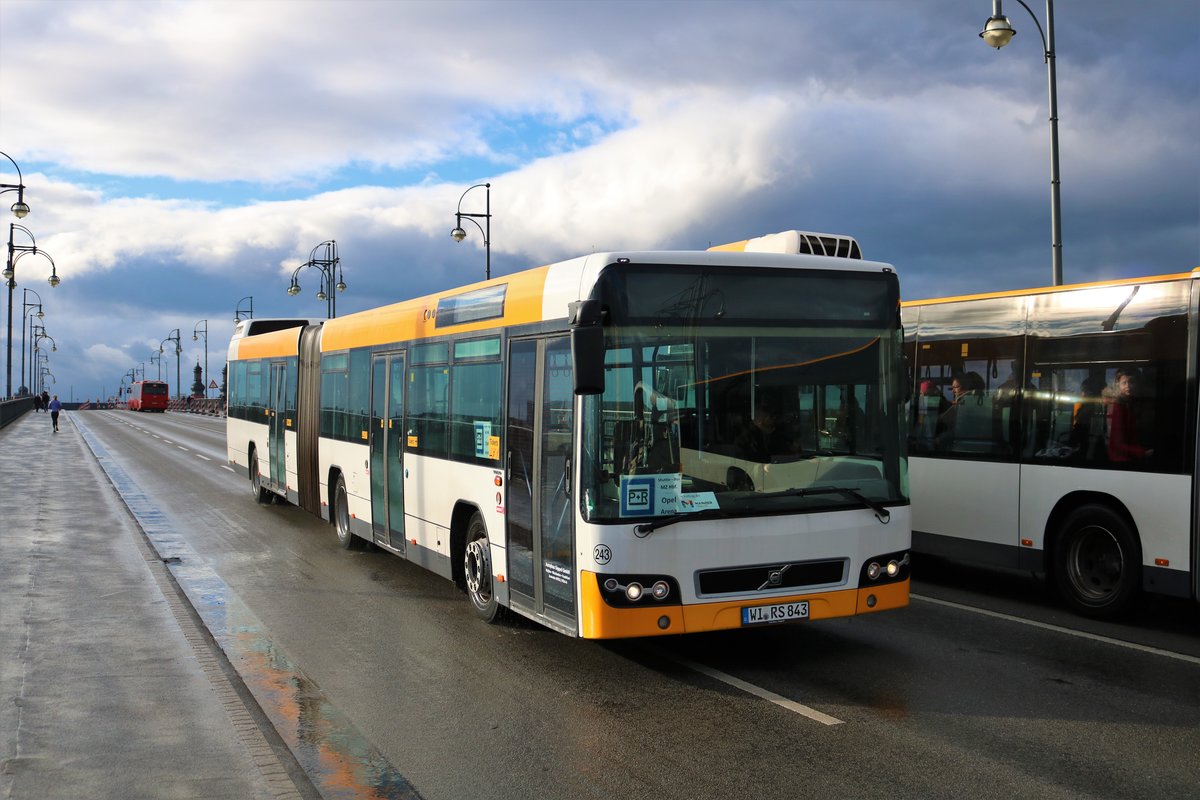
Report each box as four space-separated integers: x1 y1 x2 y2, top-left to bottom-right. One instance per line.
80 411 1200 800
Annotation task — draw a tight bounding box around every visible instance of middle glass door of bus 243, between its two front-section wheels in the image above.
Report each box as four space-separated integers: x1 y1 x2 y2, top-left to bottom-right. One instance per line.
368 353 404 553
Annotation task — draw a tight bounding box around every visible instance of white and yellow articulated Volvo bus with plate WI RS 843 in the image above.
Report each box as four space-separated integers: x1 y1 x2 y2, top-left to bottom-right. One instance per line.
227 231 911 638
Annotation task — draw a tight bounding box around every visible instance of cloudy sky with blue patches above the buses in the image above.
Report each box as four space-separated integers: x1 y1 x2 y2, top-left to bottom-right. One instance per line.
0 0 1200 399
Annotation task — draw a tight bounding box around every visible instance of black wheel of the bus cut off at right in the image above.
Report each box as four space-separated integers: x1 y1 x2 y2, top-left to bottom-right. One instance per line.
1052 504 1141 618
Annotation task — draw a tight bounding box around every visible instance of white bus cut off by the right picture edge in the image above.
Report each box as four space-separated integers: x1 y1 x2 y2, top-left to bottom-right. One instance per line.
902 269 1200 616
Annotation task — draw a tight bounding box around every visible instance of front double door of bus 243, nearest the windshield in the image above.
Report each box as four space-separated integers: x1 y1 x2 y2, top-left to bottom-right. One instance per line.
505 336 575 630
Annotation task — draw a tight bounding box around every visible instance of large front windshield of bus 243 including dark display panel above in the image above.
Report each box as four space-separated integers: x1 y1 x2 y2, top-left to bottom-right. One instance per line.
581 265 907 522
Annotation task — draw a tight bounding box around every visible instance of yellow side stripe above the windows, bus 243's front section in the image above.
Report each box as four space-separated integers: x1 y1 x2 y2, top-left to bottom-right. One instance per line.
320 266 552 353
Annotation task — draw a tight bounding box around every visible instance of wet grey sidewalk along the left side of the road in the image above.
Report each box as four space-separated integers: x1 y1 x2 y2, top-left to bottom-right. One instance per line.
0 411 301 800
